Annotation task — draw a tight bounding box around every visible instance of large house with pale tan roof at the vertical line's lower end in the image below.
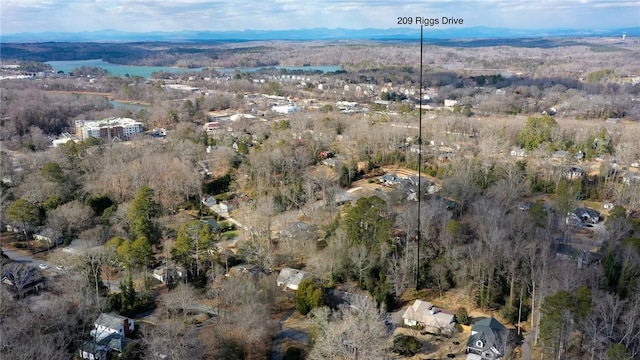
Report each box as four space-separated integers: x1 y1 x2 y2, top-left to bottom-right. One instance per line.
402 300 455 336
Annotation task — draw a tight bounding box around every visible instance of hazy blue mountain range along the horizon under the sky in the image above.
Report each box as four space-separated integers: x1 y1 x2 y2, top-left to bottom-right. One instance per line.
0 27 640 43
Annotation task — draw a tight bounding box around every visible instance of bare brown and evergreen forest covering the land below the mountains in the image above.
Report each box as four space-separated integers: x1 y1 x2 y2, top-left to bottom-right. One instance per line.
0 40 640 359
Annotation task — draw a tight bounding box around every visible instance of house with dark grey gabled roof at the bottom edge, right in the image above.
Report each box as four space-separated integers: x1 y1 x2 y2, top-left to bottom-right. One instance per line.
467 317 508 360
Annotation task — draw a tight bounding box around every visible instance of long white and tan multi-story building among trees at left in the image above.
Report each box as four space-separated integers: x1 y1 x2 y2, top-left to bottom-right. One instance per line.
76 118 144 140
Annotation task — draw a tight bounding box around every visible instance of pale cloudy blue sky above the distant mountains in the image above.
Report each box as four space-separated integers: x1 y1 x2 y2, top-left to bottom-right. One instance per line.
0 0 640 34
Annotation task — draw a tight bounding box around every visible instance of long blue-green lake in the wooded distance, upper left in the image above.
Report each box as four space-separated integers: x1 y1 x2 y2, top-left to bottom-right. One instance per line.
47 59 341 78
